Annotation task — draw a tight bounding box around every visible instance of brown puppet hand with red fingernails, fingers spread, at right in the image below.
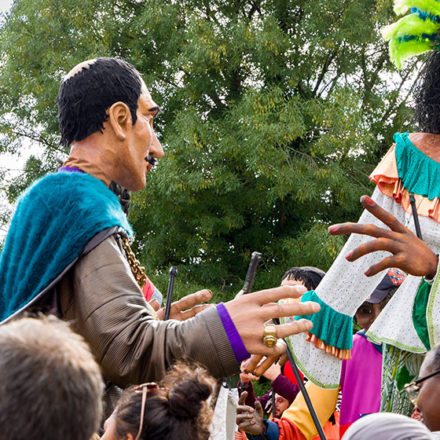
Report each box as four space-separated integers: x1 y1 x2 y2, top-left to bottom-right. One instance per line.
328 196 438 278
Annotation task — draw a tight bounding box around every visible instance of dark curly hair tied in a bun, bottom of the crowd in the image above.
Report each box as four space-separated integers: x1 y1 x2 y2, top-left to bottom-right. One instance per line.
115 363 215 440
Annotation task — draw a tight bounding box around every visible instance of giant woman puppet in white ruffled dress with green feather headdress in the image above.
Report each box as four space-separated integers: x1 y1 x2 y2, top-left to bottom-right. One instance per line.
290 0 440 413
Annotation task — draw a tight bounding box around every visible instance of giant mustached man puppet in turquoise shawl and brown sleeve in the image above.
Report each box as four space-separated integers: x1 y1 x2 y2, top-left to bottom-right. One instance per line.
0 58 319 386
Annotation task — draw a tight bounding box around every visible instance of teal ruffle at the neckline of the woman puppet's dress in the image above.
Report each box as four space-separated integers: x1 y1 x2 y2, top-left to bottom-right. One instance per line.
394 133 440 200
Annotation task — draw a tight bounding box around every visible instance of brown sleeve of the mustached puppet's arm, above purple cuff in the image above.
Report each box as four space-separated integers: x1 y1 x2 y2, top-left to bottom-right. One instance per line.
57 236 239 387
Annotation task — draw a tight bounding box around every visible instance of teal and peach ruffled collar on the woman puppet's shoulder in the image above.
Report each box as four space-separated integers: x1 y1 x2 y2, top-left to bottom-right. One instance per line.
370 133 440 223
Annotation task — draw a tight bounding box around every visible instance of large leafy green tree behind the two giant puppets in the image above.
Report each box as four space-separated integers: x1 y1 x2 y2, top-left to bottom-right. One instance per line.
0 0 416 299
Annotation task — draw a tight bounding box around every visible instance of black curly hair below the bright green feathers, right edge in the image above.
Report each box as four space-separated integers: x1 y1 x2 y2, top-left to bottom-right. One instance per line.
413 51 440 134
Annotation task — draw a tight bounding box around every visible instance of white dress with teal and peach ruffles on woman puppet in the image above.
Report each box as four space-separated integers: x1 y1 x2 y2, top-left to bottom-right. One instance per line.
284 133 440 409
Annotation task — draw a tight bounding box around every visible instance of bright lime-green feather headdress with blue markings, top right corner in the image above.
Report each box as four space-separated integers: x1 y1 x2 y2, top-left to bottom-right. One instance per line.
382 0 440 69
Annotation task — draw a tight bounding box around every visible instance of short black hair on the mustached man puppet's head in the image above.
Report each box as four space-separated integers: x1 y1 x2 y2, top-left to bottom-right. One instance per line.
57 58 142 146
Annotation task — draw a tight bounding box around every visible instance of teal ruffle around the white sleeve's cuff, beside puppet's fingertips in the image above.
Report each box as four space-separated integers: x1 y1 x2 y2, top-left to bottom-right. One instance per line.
295 290 353 350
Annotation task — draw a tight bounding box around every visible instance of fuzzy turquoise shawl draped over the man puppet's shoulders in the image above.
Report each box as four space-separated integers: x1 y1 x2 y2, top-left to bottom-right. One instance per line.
0 172 132 322
